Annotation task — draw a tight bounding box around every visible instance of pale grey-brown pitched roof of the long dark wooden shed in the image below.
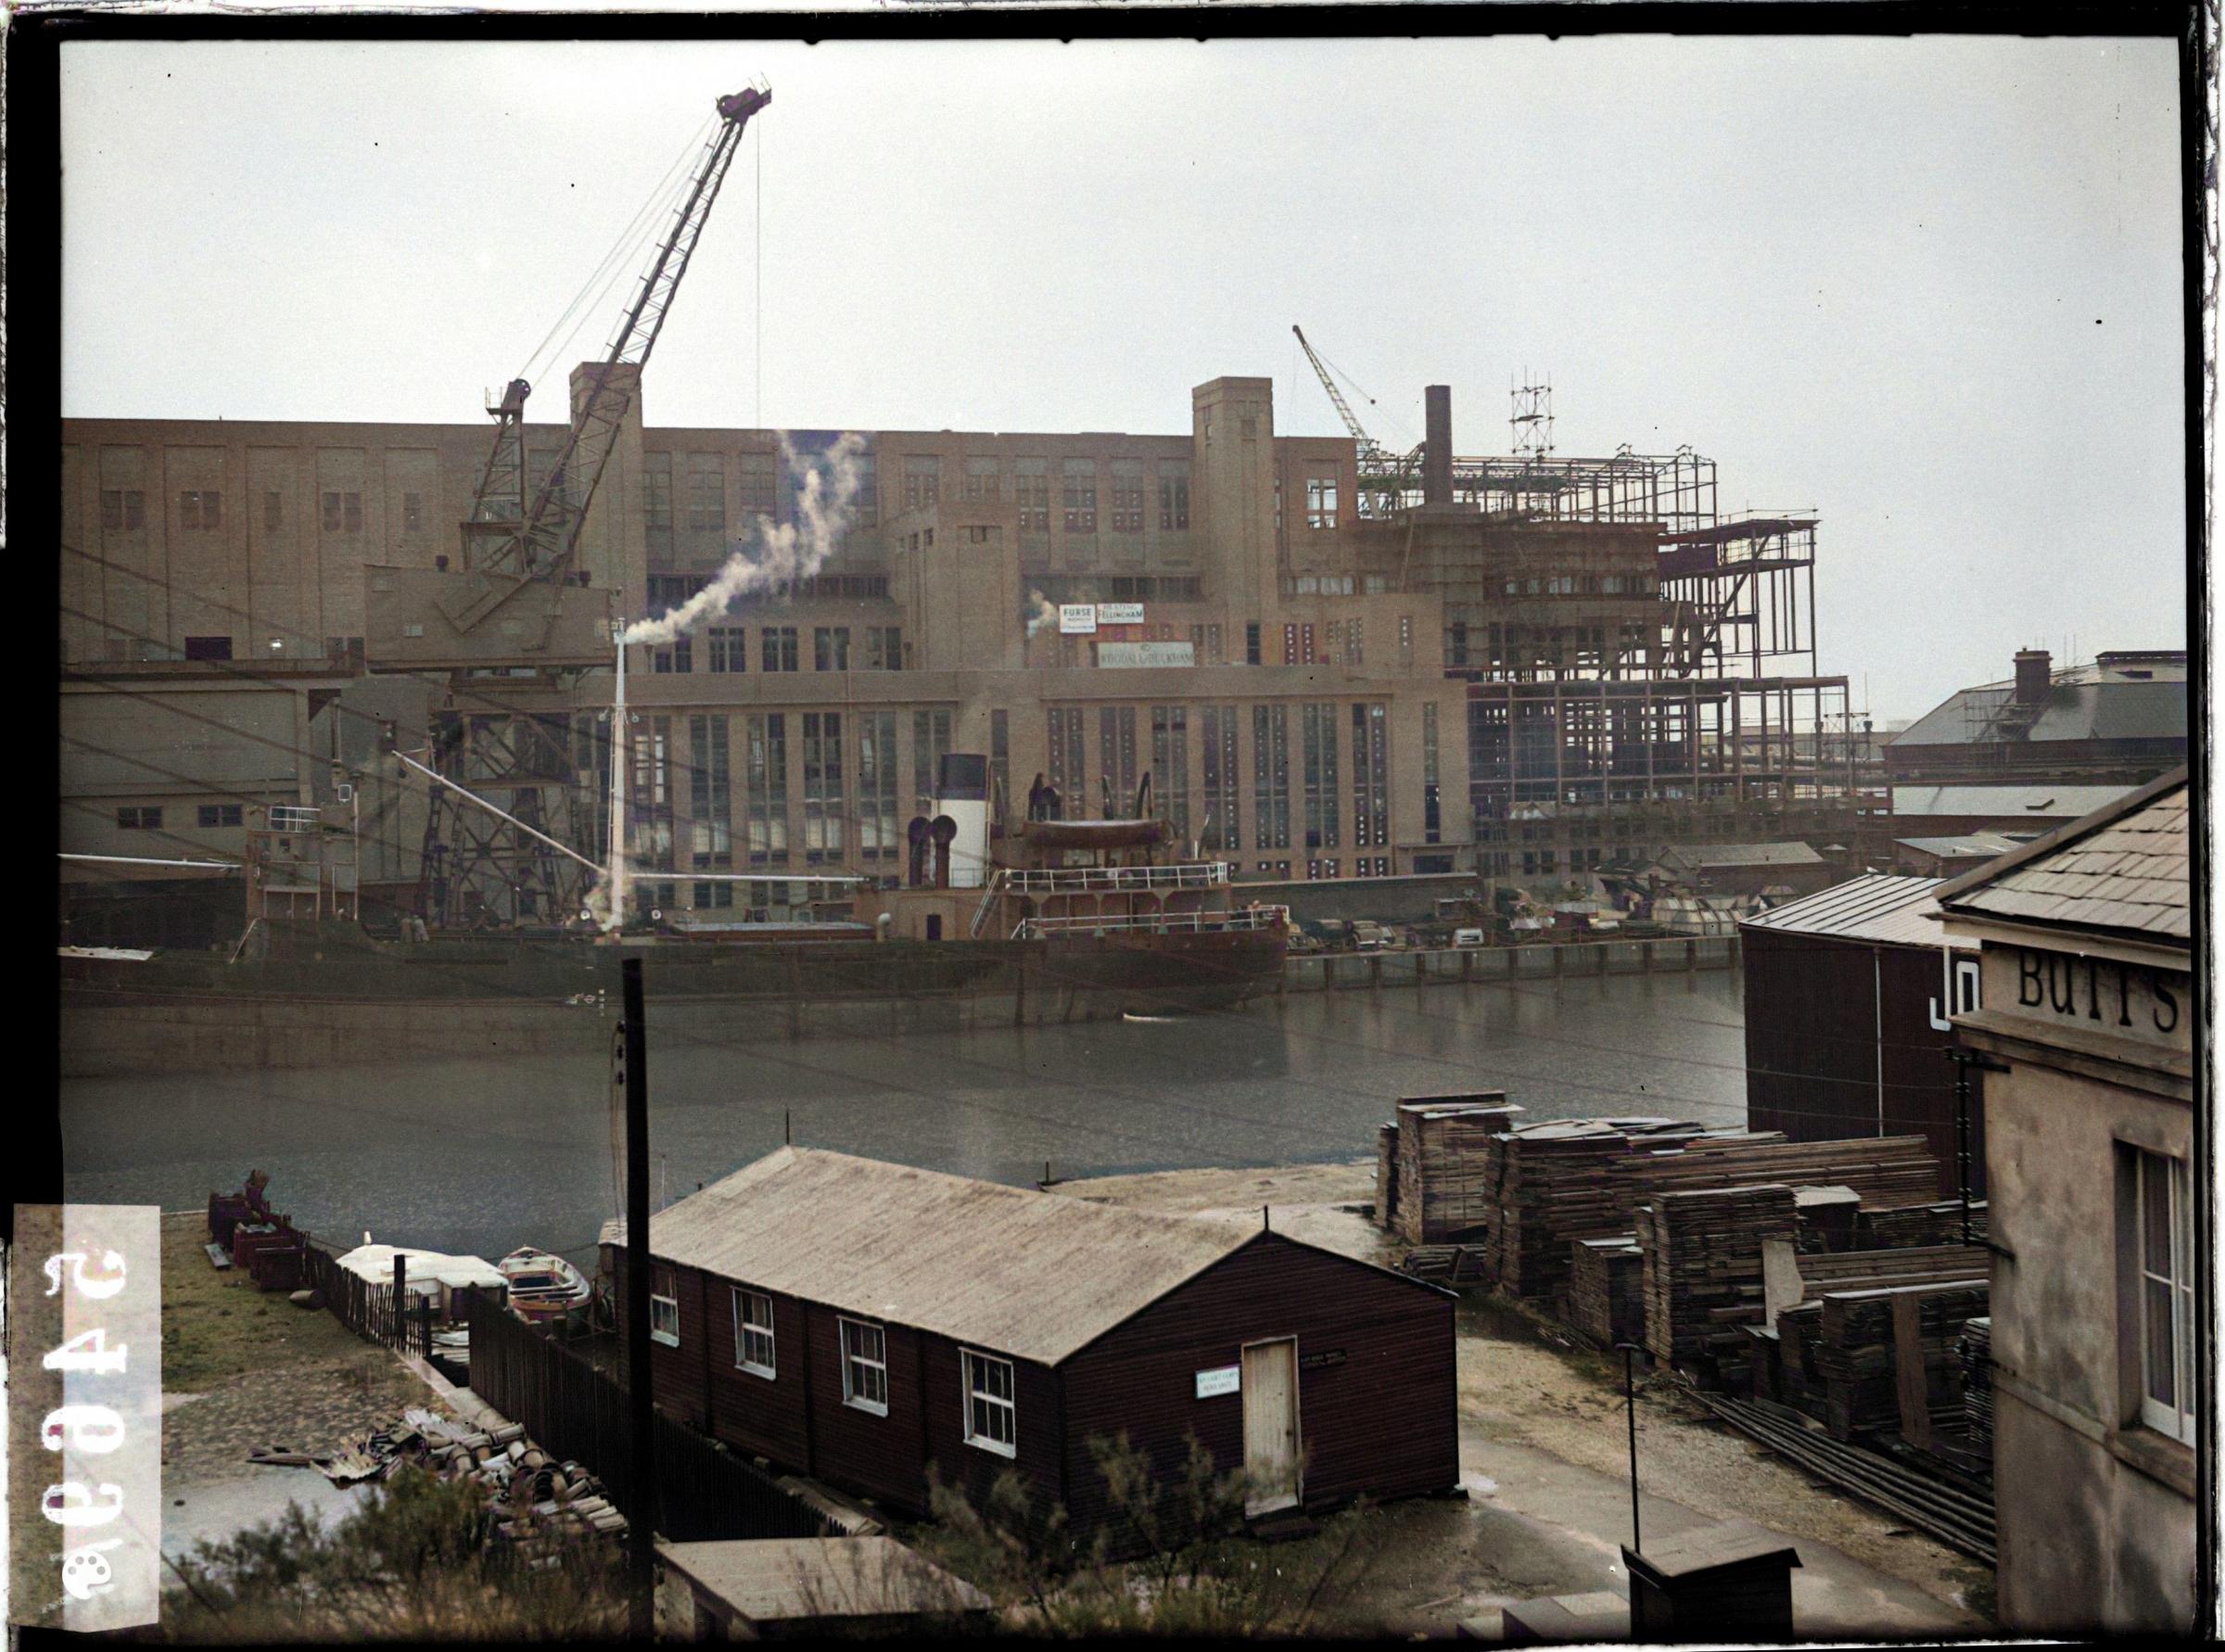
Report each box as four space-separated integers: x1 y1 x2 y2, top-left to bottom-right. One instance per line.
603 1147 1290 1365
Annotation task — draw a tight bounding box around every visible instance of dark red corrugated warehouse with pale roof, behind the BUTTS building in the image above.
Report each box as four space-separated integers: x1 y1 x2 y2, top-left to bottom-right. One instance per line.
1740 875 1985 1198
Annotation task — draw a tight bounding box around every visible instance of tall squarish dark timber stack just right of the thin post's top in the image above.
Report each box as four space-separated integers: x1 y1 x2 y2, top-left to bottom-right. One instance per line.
1635 1182 1798 1371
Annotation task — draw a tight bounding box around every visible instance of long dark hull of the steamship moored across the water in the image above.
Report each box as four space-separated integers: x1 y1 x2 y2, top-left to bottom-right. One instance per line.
62 931 1284 1077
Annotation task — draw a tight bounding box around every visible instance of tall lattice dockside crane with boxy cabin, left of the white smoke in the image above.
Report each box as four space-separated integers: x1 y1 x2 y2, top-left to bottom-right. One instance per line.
365 87 772 928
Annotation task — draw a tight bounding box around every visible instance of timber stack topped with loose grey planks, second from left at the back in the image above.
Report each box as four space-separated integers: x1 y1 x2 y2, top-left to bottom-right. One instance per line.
1484 1118 1707 1303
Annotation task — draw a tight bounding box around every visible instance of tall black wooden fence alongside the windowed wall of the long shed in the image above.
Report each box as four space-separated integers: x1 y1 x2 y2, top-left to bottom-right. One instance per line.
458 1291 839 1543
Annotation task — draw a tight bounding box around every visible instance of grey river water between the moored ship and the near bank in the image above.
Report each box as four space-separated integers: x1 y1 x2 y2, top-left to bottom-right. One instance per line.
62 971 1745 1263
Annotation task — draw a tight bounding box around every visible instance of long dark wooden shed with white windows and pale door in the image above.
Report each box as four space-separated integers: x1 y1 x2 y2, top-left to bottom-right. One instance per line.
603 1147 1459 1541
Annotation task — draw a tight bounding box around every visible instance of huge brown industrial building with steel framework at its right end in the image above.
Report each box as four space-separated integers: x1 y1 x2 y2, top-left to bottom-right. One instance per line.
60 367 1853 939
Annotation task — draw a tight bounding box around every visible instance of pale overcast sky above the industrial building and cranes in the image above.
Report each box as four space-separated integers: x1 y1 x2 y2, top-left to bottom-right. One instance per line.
62 35 2187 724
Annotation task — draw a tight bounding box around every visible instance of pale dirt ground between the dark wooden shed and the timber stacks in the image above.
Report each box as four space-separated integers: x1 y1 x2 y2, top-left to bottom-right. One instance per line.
1057 1160 1993 1634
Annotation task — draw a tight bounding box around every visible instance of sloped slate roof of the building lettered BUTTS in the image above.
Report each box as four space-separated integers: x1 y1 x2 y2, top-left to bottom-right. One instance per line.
1938 766 2192 942
